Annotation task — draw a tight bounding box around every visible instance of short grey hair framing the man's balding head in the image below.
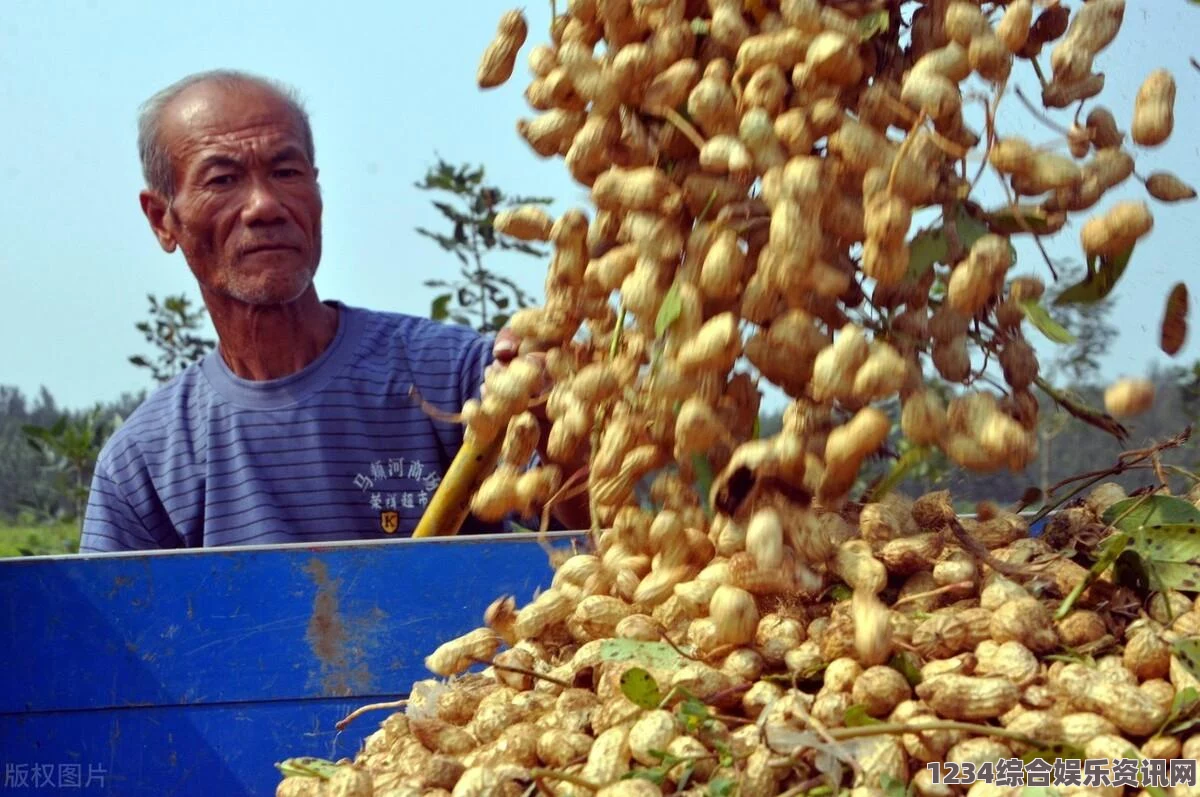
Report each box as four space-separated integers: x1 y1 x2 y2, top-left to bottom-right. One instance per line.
138 70 316 198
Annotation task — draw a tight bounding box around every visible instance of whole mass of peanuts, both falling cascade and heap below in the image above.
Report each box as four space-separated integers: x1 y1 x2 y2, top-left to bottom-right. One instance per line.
277 0 1200 797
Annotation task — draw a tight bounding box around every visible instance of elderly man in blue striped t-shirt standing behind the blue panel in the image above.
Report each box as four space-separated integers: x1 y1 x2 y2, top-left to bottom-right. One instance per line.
80 72 573 551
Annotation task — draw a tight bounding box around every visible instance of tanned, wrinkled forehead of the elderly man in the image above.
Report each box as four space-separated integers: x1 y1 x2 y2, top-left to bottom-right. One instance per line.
162 84 305 166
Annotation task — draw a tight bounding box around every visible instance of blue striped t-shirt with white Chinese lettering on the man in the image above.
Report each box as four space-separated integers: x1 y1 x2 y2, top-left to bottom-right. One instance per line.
79 302 494 551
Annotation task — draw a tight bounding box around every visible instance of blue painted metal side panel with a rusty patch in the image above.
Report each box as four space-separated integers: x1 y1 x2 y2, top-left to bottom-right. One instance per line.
0 534 578 797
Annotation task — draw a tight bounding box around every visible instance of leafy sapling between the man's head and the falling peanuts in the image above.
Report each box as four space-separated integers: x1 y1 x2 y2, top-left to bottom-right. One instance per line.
415 157 553 334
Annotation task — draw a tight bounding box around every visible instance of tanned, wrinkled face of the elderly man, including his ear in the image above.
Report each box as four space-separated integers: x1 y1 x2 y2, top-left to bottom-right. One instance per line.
142 84 322 306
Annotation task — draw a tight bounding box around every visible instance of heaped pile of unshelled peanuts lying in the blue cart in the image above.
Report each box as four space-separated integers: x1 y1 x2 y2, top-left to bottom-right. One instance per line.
276 484 1200 797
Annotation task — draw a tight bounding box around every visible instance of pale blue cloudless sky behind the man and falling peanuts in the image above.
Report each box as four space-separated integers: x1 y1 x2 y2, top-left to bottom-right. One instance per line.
0 0 1200 407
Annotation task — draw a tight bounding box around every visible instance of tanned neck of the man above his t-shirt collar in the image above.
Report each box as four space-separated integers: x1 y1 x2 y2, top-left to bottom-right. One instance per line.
205 287 338 382
